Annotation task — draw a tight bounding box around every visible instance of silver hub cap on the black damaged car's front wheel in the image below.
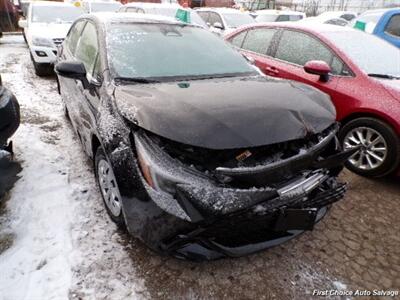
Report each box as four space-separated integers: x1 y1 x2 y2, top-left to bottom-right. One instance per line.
98 160 121 217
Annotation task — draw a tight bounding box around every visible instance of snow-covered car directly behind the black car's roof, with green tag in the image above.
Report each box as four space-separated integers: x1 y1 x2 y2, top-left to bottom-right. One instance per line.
118 2 208 28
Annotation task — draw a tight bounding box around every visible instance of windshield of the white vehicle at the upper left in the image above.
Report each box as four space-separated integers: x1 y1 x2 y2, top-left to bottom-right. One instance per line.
32 6 83 23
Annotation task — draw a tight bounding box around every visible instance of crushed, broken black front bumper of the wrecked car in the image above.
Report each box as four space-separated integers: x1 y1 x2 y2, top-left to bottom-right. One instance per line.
135 129 354 260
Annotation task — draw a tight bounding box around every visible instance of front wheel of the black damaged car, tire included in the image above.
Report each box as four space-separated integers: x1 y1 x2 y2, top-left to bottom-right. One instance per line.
95 146 125 227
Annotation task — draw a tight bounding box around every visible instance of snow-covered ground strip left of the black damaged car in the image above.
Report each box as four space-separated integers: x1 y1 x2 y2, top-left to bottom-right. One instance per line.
0 36 146 300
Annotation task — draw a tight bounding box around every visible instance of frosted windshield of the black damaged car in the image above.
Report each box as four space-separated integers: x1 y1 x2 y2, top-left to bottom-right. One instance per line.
107 24 257 80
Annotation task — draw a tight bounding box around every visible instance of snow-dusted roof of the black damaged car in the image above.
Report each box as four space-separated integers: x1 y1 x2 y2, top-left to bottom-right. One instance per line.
90 12 189 26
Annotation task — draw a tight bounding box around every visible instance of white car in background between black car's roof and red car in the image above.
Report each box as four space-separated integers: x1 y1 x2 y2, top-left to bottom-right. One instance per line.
196 7 256 36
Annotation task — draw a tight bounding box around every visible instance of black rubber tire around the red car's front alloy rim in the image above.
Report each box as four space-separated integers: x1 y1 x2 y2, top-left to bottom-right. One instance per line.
339 117 400 178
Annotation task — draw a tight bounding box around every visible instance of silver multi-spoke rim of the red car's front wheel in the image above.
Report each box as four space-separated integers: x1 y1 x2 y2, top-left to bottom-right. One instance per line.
343 127 387 170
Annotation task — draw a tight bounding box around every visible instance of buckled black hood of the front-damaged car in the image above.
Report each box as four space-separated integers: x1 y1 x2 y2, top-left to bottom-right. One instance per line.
115 76 336 149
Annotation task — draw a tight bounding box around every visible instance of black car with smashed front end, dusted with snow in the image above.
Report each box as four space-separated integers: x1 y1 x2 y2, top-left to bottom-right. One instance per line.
55 14 356 260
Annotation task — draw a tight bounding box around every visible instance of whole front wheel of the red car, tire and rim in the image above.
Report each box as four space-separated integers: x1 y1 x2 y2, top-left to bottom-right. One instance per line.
339 118 400 178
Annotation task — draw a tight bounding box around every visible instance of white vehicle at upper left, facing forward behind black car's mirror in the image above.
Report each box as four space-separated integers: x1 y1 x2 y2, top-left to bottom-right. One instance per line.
19 1 83 76
